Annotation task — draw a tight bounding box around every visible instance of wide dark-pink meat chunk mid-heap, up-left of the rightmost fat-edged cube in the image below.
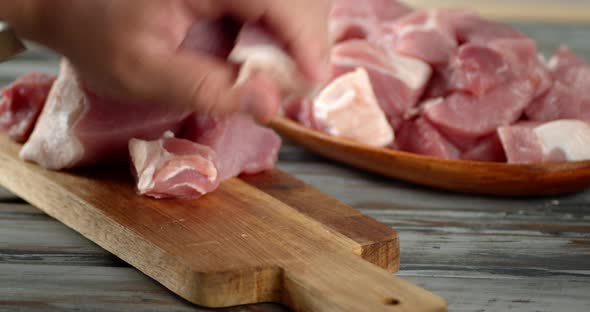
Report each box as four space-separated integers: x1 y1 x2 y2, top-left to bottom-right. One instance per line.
424 81 534 148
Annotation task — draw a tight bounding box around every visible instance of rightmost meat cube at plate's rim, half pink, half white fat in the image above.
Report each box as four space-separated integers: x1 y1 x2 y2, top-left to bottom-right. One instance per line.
498 119 590 163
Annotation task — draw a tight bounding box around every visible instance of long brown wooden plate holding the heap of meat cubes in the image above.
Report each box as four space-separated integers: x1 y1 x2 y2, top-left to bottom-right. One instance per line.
271 118 590 196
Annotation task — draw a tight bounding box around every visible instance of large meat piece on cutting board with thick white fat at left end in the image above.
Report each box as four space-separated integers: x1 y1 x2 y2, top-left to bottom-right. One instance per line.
20 60 191 170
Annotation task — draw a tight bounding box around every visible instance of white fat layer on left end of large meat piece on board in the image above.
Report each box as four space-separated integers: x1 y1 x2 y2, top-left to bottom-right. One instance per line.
20 59 85 170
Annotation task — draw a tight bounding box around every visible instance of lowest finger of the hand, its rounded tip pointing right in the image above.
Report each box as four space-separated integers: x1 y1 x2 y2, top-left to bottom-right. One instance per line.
138 52 279 122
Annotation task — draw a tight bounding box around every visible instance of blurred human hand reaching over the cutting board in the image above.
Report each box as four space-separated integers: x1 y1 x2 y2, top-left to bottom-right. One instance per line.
9 0 330 121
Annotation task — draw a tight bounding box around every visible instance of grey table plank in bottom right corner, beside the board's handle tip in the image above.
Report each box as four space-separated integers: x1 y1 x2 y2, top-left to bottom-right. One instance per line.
400 270 590 312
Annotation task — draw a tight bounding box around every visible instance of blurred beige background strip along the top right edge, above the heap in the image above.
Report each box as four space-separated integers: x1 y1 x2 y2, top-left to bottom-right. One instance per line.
404 0 590 23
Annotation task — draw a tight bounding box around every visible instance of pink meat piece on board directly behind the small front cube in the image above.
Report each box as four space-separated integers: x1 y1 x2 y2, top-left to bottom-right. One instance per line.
182 114 281 181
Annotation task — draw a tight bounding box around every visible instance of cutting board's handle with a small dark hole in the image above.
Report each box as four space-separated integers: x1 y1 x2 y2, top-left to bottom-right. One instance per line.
283 254 447 312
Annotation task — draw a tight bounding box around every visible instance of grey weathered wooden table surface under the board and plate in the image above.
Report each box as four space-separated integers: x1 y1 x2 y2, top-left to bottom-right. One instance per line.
0 23 590 312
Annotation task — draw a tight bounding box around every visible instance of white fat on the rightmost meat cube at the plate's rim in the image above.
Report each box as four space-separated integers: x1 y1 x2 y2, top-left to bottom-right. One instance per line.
534 120 590 161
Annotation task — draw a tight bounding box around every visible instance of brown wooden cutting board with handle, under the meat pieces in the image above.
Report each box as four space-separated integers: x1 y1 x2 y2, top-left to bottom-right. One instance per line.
0 135 446 312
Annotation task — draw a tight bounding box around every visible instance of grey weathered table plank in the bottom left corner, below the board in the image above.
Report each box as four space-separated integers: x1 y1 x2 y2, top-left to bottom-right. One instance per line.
0 263 286 312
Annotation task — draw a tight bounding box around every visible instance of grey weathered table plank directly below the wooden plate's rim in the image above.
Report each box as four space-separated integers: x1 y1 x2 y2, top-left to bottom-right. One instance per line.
279 161 590 211
